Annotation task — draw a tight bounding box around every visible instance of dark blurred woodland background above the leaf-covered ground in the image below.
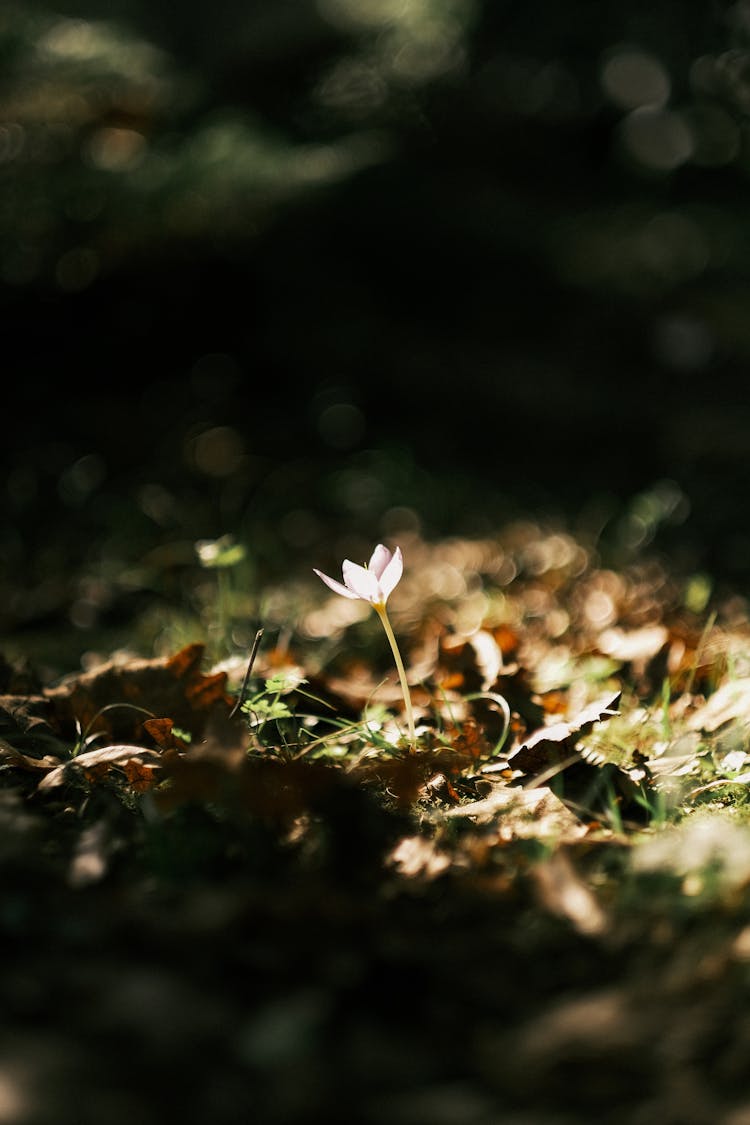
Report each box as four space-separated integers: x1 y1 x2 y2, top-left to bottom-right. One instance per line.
0 0 750 645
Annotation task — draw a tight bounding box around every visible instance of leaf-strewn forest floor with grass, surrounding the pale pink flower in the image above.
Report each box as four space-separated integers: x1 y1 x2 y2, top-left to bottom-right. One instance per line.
0 523 750 1125
